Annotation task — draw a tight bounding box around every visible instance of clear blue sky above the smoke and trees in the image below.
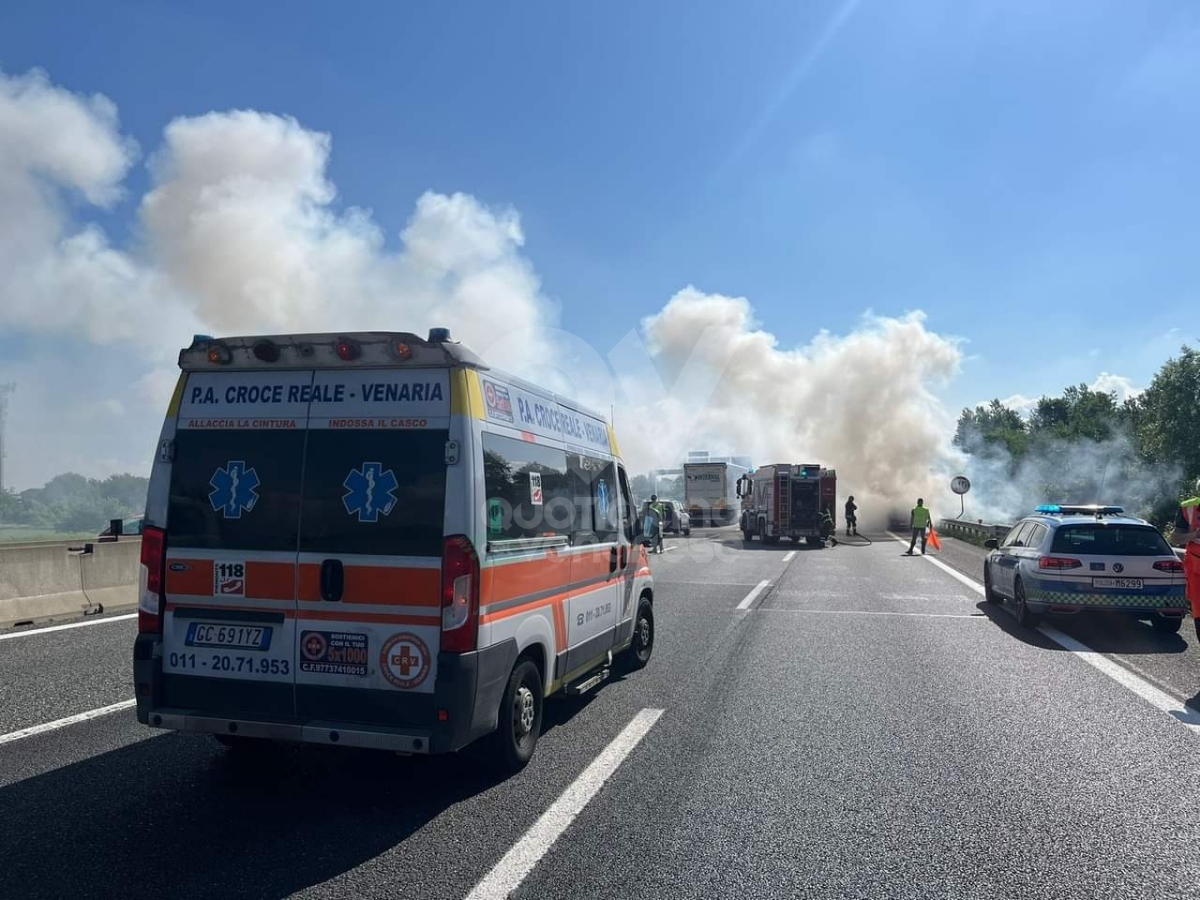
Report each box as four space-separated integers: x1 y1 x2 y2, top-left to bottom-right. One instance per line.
0 0 1200 489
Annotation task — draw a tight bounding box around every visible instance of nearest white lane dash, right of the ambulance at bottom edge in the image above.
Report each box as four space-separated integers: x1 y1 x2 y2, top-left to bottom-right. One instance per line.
467 709 664 900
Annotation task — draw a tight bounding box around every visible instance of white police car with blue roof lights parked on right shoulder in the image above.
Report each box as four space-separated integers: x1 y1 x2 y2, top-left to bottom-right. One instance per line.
983 504 1187 632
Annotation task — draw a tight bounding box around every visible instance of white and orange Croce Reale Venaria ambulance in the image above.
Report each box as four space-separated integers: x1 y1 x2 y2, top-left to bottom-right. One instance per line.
133 329 655 772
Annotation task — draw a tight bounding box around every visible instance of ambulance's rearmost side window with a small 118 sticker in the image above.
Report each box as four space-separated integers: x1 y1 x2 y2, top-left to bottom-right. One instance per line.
484 432 578 540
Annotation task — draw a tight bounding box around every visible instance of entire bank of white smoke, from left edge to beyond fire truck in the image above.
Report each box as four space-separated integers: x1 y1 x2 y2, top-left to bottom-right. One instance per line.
0 65 1104 535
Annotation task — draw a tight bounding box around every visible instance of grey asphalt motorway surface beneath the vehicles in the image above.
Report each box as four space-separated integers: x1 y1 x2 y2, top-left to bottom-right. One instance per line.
0 529 1200 900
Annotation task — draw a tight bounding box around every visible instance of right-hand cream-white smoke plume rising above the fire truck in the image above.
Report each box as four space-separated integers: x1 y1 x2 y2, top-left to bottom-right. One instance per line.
618 288 962 524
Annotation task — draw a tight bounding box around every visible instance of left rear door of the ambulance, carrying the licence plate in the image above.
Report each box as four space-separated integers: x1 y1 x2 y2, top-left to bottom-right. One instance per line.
162 371 313 720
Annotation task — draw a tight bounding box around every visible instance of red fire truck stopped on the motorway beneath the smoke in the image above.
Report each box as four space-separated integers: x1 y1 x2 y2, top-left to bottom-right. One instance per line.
740 463 838 546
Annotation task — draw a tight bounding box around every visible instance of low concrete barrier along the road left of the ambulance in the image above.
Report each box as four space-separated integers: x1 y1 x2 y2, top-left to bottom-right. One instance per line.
0 540 142 628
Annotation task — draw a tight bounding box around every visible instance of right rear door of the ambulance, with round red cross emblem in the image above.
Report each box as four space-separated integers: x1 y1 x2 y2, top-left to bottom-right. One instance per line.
295 368 461 728
